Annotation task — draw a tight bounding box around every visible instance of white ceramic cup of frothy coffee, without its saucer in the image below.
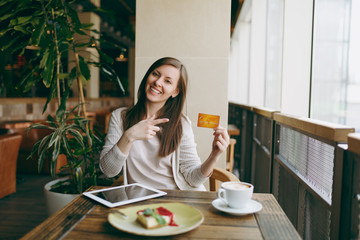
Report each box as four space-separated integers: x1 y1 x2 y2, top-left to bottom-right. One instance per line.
218 182 254 209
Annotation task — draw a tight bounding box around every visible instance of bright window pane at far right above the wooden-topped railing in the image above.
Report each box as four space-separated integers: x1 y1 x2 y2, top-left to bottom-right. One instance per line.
310 0 360 131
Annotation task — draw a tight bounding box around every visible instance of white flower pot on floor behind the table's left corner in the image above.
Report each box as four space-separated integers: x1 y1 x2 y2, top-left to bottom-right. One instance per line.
44 178 80 216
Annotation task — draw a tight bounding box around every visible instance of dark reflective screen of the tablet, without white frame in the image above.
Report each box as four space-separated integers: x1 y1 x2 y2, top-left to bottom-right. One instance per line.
93 185 157 203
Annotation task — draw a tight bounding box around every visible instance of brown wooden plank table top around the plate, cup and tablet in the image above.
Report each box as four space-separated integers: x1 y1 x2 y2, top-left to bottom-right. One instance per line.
22 188 301 239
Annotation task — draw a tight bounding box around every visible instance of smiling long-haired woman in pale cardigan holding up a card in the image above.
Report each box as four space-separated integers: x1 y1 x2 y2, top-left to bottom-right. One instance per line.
100 57 229 190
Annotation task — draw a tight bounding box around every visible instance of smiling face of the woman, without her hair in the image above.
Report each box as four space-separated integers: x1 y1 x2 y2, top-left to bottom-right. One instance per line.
145 65 180 105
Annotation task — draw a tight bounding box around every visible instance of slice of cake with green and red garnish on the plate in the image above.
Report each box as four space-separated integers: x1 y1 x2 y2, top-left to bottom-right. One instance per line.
136 207 177 229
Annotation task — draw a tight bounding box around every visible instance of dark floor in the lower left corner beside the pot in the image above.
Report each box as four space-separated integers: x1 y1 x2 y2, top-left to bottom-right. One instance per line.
0 174 52 239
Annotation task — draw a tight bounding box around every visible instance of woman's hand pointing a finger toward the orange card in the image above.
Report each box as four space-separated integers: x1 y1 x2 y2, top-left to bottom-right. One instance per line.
125 115 169 142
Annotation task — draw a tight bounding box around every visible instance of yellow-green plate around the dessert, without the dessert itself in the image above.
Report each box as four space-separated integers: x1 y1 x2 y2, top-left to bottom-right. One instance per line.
108 203 204 236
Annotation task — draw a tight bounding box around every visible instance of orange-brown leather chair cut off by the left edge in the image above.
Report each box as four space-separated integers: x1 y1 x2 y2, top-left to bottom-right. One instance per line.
0 133 22 199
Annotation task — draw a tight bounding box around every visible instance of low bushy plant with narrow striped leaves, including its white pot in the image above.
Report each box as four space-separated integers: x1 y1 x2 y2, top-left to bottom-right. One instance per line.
28 107 107 215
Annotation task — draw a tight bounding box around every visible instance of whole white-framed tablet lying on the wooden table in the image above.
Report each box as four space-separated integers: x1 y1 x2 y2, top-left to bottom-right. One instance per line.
83 183 166 207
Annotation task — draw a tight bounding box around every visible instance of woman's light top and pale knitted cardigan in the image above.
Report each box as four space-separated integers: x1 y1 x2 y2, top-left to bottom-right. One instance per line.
99 108 208 191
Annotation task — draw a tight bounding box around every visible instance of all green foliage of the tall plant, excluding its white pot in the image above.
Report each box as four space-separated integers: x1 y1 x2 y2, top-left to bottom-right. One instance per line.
0 0 123 214
